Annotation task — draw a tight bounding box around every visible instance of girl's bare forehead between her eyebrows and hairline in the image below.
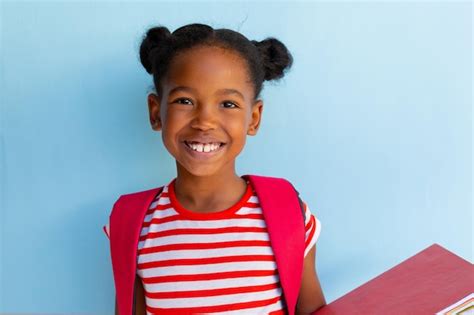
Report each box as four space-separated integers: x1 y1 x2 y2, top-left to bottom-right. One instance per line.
164 46 253 98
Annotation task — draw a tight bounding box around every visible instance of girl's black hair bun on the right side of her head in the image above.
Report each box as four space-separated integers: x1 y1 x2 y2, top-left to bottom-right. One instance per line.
252 37 293 81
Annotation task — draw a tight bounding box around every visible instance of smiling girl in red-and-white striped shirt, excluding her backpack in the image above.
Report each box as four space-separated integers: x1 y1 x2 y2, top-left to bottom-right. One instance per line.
104 24 326 315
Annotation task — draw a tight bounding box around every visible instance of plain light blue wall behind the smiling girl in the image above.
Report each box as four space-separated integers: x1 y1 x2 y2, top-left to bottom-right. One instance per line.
0 1 473 314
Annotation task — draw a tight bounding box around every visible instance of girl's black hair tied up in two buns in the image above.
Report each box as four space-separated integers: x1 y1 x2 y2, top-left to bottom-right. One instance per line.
140 23 293 99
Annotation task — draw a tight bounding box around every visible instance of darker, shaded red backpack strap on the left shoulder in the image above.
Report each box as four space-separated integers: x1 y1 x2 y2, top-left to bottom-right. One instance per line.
110 186 163 315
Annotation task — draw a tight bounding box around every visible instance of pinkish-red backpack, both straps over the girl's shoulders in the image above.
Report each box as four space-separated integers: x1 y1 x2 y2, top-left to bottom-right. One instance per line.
109 175 305 315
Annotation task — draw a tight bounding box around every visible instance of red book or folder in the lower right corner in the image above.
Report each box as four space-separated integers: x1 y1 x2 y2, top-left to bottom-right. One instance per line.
312 244 474 315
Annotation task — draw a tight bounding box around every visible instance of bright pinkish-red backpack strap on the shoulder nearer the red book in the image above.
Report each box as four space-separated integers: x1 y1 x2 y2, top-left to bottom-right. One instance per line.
243 174 305 315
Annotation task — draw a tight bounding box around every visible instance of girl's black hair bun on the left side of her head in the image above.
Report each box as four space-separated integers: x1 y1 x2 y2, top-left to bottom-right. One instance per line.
140 26 171 74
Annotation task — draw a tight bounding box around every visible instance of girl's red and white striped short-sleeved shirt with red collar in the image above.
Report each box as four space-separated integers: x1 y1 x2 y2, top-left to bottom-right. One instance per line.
103 178 321 315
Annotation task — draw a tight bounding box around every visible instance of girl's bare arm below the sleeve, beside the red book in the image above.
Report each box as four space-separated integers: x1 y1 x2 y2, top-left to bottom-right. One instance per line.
295 244 326 315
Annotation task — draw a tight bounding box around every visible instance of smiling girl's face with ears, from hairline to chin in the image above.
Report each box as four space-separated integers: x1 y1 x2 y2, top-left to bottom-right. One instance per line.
148 46 263 177
